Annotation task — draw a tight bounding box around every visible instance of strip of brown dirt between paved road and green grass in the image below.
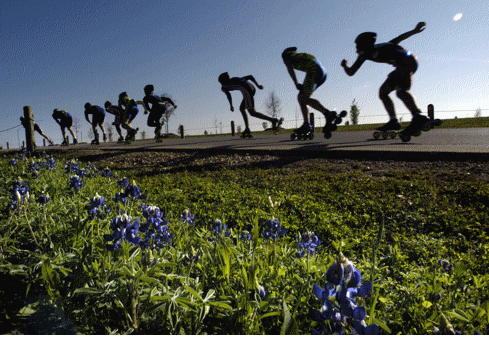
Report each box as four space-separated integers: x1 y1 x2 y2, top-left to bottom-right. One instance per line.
60 150 489 182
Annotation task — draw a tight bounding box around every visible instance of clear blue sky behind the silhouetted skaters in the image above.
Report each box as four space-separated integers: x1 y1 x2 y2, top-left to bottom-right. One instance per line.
0 0 489 146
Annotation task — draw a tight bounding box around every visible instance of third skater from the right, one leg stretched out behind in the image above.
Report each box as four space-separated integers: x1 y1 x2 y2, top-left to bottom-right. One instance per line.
218 72 283 137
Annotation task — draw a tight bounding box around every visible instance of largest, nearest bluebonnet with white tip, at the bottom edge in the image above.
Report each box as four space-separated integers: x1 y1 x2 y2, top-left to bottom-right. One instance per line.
309 253 379 334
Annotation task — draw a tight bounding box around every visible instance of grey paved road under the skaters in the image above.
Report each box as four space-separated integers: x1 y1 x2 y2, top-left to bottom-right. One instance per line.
6 128 489 161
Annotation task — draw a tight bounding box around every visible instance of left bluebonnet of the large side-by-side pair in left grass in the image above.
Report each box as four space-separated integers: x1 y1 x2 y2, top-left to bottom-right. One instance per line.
104 214 141 251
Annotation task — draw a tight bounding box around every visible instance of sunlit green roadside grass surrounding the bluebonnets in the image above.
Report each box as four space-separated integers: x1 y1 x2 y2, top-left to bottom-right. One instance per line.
0 152 489 334
